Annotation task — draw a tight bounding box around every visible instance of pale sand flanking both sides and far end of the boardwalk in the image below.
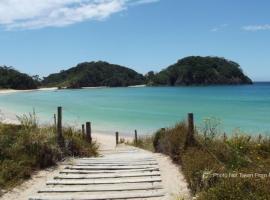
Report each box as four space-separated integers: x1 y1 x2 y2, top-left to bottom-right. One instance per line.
0 134 190 200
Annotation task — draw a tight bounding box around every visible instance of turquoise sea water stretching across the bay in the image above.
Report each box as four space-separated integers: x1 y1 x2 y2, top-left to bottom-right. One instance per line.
0 83 270 135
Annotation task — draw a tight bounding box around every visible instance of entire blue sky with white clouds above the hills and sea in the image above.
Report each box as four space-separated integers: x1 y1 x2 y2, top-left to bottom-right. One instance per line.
0 0 270 81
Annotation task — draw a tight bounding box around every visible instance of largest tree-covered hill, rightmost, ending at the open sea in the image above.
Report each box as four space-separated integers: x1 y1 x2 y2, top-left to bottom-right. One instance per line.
146 56 252 86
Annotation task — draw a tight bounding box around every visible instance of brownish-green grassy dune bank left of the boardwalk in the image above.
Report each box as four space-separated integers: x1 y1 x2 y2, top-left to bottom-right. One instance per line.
0 115 98 191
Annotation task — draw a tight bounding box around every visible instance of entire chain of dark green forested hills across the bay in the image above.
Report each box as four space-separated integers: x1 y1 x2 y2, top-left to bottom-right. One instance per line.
0 56 252 89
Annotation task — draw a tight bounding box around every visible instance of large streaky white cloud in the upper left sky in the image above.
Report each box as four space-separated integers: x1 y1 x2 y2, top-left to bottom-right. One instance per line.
0 0 159 30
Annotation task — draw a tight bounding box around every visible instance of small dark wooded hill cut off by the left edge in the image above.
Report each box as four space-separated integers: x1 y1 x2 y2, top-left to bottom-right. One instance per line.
0 66 38 90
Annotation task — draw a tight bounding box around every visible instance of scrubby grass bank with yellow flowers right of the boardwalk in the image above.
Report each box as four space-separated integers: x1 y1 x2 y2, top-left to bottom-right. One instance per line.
134 122 270 200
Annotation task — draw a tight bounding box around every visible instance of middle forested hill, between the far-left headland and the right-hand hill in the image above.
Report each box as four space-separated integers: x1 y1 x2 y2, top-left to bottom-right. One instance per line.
42 61 145 88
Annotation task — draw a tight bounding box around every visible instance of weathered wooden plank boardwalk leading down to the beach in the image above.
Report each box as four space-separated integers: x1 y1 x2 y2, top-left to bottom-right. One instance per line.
29 146 165 200
